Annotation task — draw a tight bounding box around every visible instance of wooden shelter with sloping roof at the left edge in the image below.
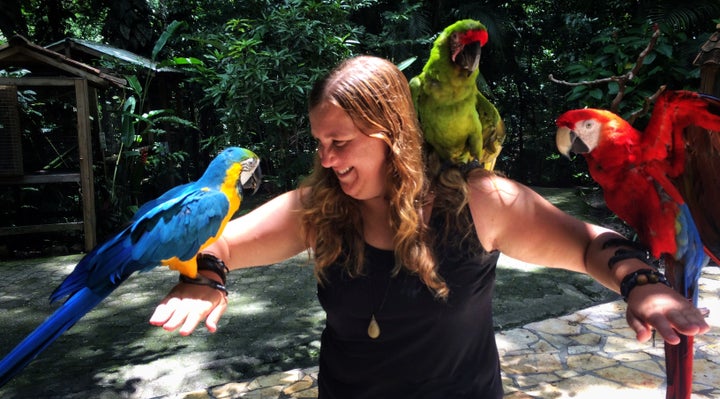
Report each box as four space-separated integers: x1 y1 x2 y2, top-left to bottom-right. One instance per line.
0 36 126 251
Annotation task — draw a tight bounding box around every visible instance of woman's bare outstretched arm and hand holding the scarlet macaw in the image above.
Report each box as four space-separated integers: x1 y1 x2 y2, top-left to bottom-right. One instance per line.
469 172 709 344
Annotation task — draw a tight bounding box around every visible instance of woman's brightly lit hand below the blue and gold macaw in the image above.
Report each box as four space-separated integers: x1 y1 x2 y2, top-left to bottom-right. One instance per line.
150 283 228 336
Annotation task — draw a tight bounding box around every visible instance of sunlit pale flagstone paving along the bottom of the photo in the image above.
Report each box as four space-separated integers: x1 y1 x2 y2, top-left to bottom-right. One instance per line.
163 267 720 399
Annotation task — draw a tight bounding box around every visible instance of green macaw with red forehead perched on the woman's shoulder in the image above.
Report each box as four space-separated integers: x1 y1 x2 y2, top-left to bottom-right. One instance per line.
410 19 505 170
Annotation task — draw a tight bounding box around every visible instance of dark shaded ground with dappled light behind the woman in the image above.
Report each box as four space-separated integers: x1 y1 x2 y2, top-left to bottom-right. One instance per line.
0 187 617 398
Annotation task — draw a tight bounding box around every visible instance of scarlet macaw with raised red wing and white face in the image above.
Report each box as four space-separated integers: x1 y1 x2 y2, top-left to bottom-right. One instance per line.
556 91 720 399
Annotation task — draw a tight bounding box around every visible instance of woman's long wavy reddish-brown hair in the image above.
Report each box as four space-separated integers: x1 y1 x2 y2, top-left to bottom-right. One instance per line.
301 56 448 298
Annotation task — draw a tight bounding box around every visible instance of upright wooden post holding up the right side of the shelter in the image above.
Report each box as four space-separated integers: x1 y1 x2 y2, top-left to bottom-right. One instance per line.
75 79 97 251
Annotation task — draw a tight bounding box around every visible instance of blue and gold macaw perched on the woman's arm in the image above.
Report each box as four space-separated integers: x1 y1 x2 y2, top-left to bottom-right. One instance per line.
0 147 259 386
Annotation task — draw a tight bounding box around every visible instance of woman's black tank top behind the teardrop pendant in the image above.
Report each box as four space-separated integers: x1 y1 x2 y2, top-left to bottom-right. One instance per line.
318 214 503 399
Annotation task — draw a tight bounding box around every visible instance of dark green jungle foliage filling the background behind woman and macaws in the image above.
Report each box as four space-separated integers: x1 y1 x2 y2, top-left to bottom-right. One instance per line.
0 0 720 256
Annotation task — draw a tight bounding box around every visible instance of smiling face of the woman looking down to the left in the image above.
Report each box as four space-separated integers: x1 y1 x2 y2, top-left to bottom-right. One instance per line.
310 102 388 200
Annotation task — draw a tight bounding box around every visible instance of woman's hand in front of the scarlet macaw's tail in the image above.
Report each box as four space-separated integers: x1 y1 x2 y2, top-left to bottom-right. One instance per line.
626 284 710 345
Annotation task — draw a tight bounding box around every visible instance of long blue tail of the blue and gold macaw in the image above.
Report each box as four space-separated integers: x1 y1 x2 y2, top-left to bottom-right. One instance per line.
0 288 107 387
